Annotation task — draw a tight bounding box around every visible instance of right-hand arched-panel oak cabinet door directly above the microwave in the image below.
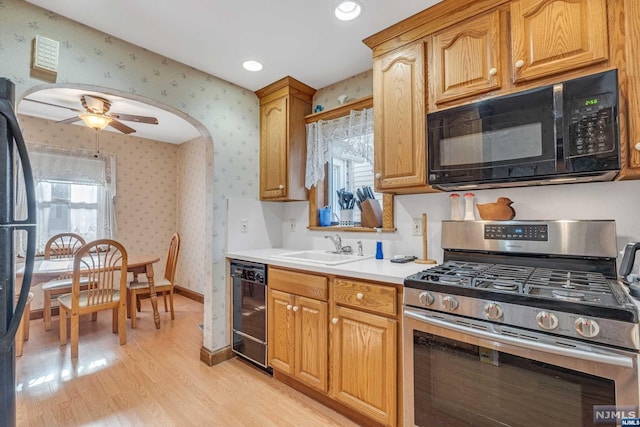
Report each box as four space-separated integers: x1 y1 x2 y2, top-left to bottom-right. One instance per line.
511 0 609 82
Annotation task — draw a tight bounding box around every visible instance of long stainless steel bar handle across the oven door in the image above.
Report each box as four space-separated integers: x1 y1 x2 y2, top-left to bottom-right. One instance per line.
404 308 633 368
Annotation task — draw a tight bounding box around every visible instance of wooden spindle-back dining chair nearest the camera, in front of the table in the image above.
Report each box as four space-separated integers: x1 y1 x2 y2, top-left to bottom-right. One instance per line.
58 239 127 357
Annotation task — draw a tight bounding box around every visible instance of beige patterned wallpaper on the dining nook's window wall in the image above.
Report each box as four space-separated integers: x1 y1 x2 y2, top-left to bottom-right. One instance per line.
20 116 180 309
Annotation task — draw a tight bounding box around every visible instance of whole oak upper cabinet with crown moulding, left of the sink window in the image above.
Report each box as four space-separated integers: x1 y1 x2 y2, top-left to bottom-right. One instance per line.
256 77 315 201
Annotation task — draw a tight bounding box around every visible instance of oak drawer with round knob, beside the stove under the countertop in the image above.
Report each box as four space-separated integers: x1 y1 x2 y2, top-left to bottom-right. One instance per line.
334 279 397 316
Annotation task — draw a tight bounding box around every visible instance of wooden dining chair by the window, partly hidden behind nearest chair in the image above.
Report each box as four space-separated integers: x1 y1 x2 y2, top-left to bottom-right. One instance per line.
42 233 87 331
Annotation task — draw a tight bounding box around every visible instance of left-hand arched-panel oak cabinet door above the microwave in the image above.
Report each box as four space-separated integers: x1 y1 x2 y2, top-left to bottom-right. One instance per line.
429 11 501 104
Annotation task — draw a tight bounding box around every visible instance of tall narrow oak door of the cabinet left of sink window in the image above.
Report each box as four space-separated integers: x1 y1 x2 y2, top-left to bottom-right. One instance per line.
260 96 289 199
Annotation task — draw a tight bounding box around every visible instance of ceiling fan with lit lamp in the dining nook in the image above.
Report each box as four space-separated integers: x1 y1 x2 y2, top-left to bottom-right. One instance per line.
24 94 158 135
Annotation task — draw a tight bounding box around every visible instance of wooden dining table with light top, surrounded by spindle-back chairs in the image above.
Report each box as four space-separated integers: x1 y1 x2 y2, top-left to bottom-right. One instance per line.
16 254 160 329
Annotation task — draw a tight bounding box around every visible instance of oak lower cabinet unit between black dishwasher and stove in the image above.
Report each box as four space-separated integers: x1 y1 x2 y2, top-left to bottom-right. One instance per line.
267 267 401 426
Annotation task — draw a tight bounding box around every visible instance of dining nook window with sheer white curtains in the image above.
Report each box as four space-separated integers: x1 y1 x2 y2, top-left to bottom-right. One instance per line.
28 144 116 252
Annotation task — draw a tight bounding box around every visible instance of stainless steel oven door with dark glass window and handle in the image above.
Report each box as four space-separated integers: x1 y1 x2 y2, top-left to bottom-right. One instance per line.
403 307 638 427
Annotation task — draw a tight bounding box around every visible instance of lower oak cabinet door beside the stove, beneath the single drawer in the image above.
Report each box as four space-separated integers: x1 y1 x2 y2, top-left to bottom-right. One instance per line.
331 307 397 425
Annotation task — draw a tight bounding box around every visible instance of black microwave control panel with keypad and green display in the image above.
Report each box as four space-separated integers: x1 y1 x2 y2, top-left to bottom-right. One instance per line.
568 93 616 157
